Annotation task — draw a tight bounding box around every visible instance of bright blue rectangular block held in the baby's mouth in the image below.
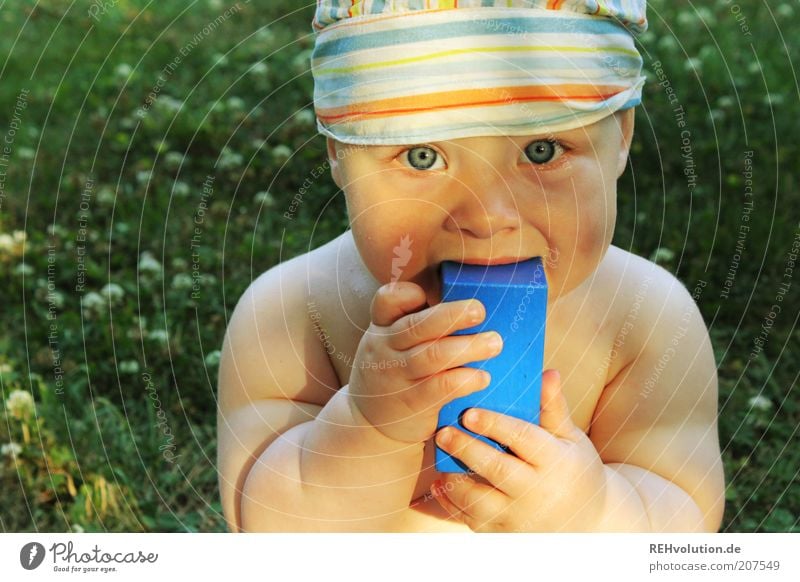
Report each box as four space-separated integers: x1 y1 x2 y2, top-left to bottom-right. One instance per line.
436 257 547 473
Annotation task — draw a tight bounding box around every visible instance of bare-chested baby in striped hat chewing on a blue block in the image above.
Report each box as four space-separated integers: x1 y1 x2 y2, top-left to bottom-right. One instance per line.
218 0 724 532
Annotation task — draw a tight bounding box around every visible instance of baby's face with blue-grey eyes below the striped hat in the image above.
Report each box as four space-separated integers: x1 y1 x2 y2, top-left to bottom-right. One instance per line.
329 109 633 305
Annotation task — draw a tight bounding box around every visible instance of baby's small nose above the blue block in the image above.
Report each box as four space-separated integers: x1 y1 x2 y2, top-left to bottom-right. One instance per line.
446 185 521 239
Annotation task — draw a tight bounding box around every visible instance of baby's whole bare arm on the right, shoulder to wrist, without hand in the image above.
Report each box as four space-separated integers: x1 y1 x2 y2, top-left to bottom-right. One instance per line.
590 265 724 532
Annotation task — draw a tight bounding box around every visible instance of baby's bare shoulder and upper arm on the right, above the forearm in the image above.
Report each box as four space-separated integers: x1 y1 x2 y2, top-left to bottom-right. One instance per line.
590 249 724 531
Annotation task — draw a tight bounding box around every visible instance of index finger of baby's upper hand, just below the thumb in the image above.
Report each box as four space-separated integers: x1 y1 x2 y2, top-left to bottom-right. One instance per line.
389 299 486 351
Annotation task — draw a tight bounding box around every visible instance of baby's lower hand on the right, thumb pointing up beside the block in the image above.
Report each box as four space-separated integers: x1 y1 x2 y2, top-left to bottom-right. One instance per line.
431 370 606 532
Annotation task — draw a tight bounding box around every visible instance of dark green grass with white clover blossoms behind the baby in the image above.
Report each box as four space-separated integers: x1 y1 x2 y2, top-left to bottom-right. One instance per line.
0 0 800 532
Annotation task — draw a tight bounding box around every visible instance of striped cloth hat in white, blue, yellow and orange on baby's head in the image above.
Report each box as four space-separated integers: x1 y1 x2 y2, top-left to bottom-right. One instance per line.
312 0 647 145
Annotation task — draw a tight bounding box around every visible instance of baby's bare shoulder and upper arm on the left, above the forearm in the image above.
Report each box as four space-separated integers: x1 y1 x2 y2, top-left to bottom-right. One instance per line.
217 237 339 531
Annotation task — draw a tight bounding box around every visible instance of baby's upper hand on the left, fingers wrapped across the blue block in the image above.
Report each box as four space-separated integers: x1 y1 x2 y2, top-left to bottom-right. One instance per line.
349 282 502 443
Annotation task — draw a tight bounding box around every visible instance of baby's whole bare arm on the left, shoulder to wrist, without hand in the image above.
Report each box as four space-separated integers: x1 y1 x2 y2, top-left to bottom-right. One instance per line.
219 261 423 531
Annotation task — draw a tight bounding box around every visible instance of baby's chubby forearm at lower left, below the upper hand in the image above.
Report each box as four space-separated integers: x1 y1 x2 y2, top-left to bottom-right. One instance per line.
242 386 424 532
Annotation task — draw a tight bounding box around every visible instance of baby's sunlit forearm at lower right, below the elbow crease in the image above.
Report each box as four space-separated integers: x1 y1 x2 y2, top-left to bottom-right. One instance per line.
598 463 716 532
